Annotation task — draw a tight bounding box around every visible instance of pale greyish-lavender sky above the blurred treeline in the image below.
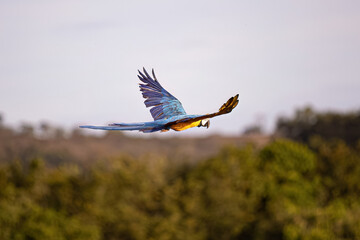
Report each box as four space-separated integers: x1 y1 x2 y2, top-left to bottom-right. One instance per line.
0 0 360 136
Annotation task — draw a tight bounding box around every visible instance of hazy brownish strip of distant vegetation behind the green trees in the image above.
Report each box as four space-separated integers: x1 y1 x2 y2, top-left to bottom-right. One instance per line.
0 115 270 167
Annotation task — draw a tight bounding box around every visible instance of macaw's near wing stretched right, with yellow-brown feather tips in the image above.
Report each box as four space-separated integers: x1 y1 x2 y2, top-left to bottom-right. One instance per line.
165 94 239 127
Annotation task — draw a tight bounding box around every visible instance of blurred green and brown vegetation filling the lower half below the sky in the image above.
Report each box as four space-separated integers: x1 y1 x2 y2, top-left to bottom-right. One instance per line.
0 108 360 240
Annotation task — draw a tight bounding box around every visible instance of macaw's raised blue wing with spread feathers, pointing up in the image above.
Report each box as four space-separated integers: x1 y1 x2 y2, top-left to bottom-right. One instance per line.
138 68 186 120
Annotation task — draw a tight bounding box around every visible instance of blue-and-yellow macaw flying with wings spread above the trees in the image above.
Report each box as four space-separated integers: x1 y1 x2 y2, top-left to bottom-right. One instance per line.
80 68 239 133
